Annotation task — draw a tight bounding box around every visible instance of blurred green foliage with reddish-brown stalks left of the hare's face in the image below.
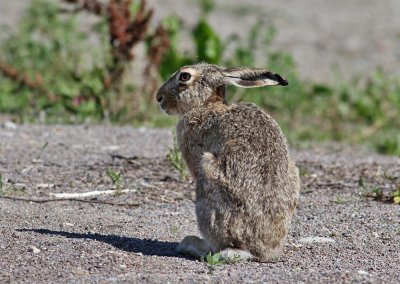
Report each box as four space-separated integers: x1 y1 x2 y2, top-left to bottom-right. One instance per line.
0 0 152 122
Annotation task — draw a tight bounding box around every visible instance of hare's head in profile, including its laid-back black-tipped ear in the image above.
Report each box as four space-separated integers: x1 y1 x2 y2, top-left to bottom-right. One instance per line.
156 63 288 115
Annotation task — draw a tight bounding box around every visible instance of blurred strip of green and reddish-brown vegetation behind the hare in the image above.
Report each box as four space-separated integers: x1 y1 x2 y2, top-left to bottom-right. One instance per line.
0 0 400 156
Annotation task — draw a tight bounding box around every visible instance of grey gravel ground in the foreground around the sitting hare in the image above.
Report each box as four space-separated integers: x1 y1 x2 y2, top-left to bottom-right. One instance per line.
0 124 400 283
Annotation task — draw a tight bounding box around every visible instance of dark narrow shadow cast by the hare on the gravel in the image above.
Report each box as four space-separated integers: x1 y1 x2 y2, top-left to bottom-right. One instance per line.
17 229 186 258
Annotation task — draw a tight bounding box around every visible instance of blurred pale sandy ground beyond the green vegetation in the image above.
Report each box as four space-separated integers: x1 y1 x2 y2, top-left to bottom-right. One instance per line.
0 0 400 83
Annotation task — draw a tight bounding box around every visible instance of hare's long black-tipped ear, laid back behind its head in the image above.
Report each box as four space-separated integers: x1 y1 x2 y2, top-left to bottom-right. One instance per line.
222 67 289 88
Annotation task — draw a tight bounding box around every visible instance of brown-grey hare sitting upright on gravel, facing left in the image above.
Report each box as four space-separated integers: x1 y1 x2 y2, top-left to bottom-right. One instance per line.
156 63 300 262
